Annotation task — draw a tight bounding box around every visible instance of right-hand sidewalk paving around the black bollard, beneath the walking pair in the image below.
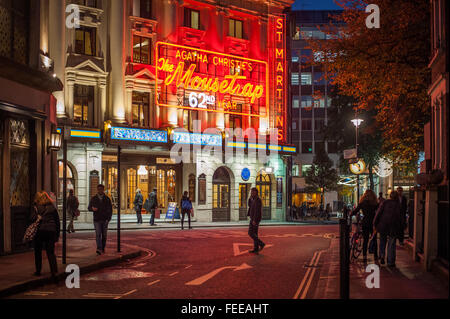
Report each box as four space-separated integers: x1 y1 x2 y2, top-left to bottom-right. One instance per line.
313 238 449 299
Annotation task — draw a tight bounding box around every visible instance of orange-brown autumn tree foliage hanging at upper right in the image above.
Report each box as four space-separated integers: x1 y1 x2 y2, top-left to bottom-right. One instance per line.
309 0 430 169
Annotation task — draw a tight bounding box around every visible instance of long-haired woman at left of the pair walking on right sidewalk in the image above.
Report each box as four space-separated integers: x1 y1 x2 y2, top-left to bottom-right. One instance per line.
351 189 378 262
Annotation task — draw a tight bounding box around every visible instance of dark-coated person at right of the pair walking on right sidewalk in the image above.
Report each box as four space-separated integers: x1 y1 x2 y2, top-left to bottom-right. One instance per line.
373 191 403 267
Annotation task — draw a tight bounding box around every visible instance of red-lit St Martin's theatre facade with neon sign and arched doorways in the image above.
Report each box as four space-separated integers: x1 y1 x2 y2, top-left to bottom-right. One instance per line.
49 0 296 222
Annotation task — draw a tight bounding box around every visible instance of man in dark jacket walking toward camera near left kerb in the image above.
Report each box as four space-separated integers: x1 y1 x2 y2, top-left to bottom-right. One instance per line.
88 184 112 255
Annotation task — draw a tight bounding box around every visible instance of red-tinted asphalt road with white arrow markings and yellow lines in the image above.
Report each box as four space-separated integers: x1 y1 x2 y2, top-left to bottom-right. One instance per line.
10 225 338 299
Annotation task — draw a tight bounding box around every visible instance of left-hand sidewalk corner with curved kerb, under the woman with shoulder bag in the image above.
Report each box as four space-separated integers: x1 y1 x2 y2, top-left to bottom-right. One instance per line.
0 238 142 298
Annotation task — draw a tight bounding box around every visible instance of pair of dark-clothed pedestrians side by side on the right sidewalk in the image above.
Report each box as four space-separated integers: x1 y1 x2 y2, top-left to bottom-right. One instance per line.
351 187 407 267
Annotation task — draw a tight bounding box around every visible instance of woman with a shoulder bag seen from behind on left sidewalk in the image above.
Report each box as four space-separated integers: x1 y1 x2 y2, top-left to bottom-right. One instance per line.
31 191 60 283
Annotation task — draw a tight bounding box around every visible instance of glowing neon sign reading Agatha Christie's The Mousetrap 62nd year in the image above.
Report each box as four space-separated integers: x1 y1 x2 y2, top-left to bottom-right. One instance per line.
156 42 269 117
